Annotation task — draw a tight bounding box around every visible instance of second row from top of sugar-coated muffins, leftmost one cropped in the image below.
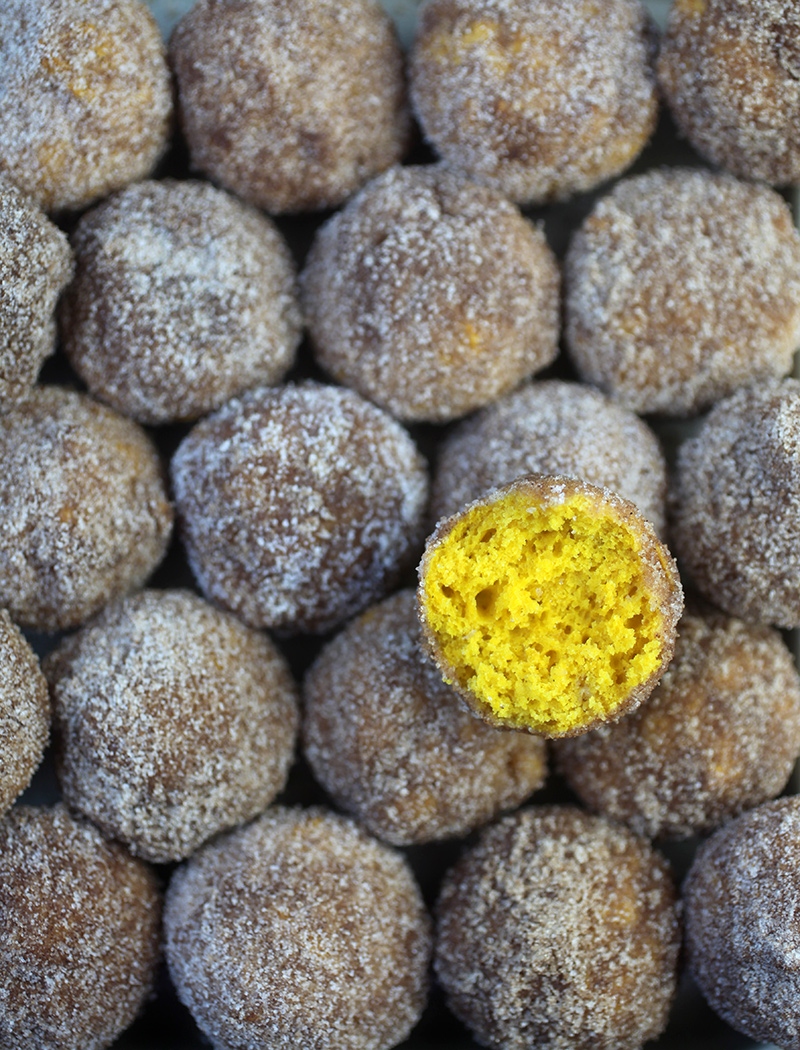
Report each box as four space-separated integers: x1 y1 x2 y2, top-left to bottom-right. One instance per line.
6 160 800 424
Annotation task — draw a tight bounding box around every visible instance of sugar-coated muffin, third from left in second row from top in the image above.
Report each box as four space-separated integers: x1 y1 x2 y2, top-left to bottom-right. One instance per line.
302 165 560 422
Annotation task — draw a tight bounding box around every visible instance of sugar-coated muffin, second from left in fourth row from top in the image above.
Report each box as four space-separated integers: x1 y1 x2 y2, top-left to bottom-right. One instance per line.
45 591 297 862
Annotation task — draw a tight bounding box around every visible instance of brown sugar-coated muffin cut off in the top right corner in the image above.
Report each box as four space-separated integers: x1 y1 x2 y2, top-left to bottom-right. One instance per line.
658 0 800 186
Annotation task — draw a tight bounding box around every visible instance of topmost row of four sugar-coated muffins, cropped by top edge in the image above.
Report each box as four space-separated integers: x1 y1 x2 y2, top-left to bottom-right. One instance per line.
0 0 800 212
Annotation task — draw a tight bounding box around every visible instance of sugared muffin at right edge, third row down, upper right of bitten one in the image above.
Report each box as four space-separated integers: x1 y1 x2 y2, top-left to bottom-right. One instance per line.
672 379 800 628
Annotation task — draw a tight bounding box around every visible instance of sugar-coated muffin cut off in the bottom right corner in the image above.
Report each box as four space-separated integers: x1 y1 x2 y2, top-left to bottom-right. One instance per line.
683 797 800 1048
